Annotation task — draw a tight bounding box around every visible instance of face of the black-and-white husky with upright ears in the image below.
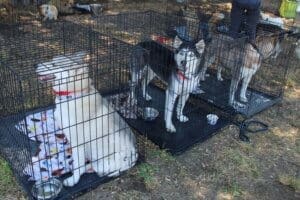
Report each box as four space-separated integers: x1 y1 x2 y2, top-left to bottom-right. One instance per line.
173 37 205 75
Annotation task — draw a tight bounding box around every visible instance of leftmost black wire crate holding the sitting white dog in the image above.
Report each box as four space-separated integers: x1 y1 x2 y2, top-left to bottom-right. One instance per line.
0 22 144 199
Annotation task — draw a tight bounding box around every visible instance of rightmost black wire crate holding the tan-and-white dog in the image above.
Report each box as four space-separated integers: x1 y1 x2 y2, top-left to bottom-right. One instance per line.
198 22 293 118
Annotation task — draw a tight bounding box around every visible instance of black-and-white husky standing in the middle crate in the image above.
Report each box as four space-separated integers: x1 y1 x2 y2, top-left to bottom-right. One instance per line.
130 37 205 132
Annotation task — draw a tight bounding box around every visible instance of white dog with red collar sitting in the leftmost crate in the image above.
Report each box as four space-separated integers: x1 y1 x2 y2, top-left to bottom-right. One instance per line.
36 52 137 186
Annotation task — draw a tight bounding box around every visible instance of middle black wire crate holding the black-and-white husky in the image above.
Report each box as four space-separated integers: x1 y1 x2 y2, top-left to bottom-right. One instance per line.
94 11 229 154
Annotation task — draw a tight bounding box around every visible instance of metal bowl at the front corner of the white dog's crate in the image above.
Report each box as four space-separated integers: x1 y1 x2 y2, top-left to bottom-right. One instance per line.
31 178 62 200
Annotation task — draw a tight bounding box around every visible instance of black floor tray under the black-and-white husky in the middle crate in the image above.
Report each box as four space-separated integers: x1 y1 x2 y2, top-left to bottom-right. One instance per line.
127 84 230 154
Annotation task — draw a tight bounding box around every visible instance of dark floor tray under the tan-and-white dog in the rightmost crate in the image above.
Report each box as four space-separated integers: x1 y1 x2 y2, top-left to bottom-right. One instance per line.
196 73 280 118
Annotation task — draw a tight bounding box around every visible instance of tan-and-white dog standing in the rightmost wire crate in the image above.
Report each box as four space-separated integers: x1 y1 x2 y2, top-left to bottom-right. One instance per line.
200 30 281 108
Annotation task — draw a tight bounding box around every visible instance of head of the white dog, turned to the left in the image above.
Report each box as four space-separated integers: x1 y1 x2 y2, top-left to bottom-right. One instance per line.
36 53 90 91
